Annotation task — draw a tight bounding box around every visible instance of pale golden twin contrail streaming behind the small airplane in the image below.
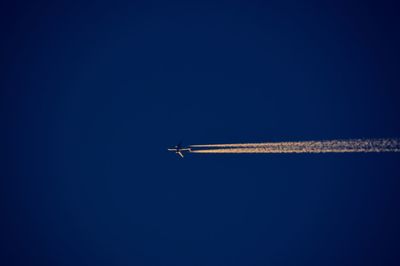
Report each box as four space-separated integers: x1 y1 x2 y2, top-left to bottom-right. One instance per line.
189 139 400 153
